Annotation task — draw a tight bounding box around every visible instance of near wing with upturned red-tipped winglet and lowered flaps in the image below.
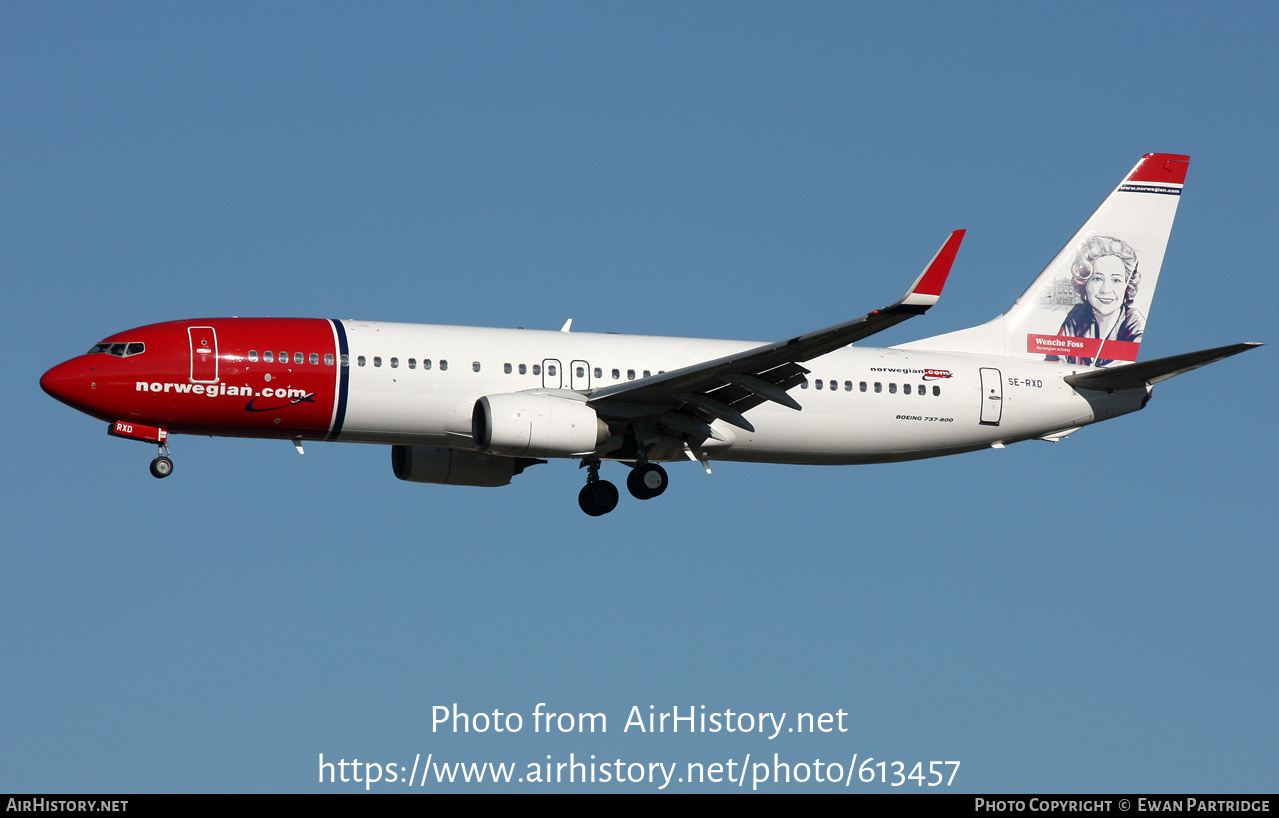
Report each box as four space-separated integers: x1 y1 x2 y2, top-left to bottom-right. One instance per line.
587 230 964 437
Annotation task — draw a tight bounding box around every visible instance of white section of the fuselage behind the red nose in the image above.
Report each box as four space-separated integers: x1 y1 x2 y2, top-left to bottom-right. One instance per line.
339 321 1147 465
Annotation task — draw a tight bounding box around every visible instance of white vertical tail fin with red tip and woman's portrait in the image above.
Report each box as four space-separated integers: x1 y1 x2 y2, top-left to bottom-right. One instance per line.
903 153 1189 367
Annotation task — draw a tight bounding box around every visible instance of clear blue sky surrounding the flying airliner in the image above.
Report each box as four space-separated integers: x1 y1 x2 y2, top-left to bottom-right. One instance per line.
0 3 1279 792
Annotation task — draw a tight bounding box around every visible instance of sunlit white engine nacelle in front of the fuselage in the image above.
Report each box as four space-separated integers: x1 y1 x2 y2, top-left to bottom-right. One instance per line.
471 392 609 458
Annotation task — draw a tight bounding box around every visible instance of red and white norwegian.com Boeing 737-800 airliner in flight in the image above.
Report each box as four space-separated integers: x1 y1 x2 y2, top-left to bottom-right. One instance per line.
40 153 1260 516
